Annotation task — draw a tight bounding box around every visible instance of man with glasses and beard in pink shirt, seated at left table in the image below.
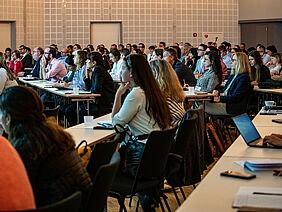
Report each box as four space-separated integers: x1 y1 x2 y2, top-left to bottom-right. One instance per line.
44 47 67 82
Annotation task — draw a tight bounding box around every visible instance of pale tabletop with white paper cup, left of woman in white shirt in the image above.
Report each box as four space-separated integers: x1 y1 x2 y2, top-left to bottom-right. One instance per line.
66 114 115 145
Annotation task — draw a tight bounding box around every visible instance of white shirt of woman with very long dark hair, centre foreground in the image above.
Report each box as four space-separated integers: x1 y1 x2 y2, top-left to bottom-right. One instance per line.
112 87 160 143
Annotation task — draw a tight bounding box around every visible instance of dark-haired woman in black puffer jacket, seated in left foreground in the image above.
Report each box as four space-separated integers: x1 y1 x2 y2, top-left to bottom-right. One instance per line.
0 86 92 207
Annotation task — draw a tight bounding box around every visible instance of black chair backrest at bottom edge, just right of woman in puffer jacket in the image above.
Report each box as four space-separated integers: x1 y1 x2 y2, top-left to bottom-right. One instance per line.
87 152 120 212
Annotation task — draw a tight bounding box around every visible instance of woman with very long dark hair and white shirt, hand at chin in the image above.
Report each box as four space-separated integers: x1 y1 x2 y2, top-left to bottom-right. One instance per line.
112 54 172 211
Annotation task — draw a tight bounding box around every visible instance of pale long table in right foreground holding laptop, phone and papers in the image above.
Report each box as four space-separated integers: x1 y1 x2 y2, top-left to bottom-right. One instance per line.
177 112 282 212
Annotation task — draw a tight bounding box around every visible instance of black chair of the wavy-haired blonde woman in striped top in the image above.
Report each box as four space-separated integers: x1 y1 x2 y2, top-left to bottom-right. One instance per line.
166 111 198 205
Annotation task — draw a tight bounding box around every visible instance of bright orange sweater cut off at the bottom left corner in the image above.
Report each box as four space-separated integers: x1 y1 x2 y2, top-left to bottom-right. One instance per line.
0 136 35 211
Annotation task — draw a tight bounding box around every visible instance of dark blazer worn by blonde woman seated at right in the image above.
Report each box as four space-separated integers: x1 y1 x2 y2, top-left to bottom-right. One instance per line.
220 73 253 114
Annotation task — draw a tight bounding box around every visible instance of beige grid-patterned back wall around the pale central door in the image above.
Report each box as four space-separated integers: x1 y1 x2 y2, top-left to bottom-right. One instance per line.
44 0 239 48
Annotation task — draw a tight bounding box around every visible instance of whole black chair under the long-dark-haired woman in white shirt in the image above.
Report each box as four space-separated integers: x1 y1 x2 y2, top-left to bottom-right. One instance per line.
110 127 176 211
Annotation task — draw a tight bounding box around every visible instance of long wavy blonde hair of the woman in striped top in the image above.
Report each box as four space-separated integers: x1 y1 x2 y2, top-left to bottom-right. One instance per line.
150 59 185 102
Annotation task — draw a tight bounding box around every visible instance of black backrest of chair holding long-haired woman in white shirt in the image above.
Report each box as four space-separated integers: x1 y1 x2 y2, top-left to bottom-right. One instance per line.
137 127 177 179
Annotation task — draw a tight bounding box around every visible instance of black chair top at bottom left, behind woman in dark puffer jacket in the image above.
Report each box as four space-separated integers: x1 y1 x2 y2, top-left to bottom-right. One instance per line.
16 191 82 212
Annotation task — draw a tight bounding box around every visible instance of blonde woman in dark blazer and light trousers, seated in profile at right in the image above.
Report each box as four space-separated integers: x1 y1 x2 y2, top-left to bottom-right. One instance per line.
205 52 252 115
